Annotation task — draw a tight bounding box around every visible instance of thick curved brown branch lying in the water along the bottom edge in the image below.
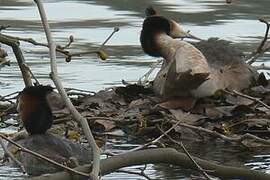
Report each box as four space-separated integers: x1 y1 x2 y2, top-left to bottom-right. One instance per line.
31 148 270 180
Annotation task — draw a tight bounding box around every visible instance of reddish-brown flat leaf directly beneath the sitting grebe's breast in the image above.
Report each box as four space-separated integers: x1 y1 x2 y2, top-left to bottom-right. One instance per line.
157 97 197 111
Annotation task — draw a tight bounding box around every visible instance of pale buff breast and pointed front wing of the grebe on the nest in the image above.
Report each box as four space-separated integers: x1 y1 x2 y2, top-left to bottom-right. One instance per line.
153 40 212 96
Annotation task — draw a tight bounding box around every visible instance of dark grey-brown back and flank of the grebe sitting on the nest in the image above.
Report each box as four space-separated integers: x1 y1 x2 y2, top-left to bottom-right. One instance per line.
193 38 259 90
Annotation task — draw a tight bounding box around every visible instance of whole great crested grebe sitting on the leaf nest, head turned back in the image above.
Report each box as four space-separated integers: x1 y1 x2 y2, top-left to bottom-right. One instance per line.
140 8 258 97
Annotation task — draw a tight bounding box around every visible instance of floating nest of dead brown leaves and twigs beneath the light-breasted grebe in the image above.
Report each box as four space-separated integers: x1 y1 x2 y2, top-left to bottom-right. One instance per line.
59 84 270 147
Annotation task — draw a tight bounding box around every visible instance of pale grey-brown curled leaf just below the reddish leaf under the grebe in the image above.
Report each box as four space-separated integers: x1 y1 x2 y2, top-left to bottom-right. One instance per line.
169 109 206 125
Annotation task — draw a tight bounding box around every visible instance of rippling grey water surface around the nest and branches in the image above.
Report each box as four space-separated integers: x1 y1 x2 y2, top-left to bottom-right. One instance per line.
0 0 270 179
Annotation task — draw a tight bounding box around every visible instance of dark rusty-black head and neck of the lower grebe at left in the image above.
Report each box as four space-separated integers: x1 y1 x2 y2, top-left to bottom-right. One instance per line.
17 85 53 135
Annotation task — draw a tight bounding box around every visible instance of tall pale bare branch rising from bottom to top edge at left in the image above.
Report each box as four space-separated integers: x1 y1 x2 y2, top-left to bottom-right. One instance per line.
34 0 100 180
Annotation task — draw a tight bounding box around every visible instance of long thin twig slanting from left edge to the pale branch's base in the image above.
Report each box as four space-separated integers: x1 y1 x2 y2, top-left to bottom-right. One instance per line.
0 134 89 177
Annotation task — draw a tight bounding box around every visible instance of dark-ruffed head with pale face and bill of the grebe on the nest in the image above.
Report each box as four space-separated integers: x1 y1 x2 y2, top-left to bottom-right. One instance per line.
140 15 189 57
